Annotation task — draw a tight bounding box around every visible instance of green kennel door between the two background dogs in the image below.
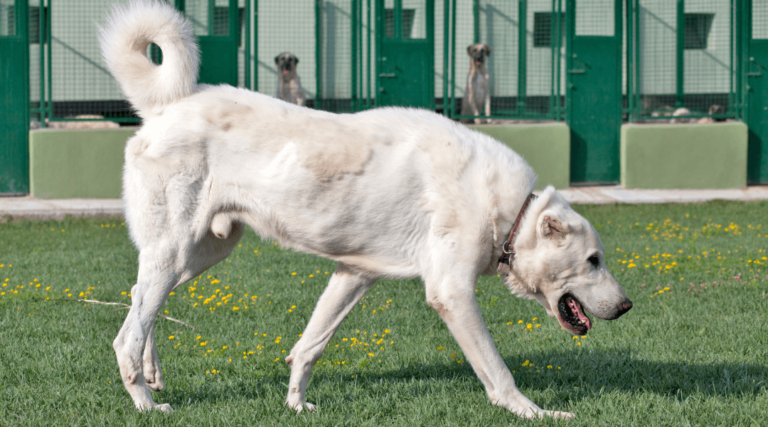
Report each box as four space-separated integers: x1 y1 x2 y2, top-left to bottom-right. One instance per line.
376 0 435 110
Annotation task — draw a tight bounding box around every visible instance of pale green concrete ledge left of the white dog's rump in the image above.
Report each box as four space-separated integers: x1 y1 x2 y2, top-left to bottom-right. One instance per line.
29 128 136 199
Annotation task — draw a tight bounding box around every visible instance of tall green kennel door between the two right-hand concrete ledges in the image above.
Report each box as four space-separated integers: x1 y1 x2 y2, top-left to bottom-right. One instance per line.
566 0 623 184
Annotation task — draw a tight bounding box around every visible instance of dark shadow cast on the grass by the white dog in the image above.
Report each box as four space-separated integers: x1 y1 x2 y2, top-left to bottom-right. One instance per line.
163 350 768 406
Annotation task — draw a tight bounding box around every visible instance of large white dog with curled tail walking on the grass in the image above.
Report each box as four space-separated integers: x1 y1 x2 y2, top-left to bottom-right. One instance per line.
101 2 631 418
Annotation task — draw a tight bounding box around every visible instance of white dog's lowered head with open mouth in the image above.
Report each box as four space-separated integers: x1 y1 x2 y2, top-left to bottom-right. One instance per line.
499 186 632 335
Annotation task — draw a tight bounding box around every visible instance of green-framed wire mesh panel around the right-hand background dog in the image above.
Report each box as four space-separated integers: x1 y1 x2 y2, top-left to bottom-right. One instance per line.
453 0 565 120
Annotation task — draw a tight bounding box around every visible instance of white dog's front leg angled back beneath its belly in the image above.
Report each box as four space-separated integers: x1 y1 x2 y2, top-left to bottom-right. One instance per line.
285 264 376 412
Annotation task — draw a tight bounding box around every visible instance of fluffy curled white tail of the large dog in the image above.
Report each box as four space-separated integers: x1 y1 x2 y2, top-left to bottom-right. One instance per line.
99 0 200 117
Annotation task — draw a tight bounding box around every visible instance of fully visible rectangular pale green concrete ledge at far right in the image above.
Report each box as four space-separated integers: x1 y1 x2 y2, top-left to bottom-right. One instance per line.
621 123 747 189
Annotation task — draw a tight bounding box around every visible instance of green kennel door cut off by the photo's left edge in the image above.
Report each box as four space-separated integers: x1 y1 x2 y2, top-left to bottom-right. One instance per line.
0 0 29 194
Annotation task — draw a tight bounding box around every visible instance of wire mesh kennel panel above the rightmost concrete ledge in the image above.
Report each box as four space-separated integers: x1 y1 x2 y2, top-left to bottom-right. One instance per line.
637 0 735 122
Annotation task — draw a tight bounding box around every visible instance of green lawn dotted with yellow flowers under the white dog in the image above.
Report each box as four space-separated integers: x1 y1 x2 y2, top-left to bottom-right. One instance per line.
0 202 768 426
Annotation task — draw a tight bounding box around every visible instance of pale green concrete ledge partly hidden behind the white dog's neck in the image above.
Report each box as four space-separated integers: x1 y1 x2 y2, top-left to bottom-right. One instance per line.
469 123 571 190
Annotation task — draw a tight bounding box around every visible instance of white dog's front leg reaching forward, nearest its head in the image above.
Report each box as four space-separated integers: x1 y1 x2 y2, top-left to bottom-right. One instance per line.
425 272 573 419
